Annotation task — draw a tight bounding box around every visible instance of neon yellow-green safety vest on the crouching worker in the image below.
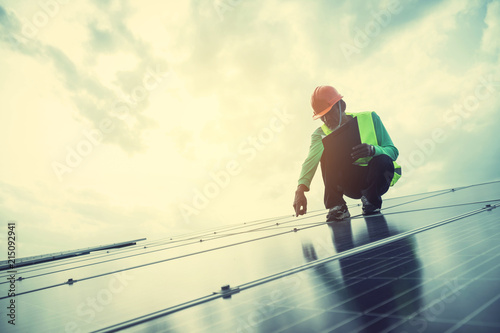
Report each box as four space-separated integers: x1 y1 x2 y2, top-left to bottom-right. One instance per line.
321 111 402 186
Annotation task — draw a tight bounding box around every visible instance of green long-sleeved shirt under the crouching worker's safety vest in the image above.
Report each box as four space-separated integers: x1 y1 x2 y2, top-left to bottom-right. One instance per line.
299 112 399 191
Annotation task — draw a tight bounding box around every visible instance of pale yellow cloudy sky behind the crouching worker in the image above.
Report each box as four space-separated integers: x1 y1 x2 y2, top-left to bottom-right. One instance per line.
0 0 500 259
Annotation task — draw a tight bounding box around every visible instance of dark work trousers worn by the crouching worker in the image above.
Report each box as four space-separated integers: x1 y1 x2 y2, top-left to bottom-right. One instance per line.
321 154 394 208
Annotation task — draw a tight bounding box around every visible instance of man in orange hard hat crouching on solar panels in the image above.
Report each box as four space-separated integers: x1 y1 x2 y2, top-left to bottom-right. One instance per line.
293 86 401 221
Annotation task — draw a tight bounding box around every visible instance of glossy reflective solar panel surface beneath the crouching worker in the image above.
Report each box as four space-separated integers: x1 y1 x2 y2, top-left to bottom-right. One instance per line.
0 182 500 332
